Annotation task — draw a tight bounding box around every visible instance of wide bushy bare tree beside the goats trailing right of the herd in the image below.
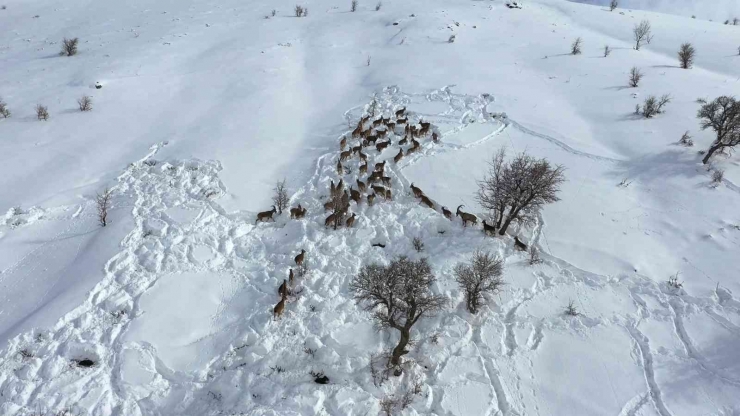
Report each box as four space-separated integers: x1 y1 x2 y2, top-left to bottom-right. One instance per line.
476 150 565 235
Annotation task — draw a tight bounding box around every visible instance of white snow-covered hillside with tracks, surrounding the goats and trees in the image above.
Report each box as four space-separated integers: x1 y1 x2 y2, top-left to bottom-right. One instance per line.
0 0 740 416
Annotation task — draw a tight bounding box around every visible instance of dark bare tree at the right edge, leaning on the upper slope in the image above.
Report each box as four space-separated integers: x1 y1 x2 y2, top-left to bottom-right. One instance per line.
696 96 740 164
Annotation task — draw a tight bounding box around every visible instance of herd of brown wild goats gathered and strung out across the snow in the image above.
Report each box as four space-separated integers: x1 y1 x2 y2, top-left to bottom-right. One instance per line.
257 106 502 318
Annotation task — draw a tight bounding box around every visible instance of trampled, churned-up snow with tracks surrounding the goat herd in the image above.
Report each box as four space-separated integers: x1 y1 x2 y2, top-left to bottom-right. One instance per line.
0 87 740 416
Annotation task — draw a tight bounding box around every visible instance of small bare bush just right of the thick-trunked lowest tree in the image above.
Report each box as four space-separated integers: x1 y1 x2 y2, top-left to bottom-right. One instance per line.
455 250 504 314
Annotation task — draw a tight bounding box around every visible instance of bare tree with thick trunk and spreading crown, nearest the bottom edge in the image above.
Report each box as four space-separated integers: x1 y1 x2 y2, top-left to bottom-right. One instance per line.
349 256 447 376
